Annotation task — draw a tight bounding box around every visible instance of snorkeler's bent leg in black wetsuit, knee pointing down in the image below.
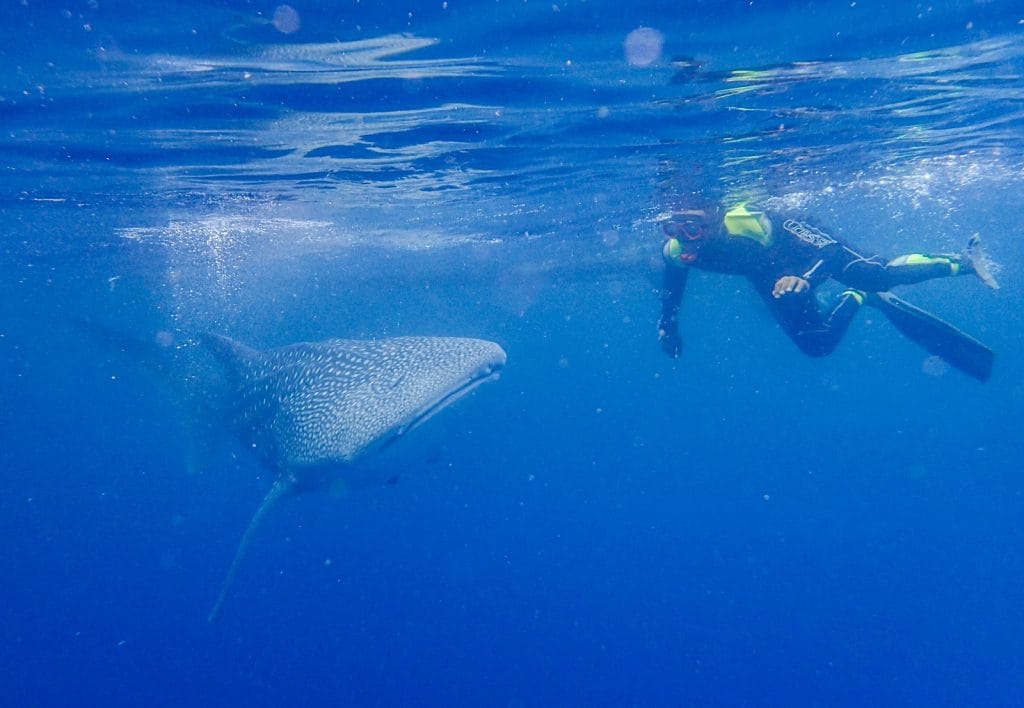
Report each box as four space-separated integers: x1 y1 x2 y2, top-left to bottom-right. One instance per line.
764 290 864 357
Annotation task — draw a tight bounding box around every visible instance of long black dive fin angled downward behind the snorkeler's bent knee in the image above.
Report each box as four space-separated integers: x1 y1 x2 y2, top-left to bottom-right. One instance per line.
870 292 995 381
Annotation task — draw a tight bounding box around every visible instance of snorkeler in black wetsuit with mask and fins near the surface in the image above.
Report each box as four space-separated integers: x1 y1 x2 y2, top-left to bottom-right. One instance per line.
657 196 999 380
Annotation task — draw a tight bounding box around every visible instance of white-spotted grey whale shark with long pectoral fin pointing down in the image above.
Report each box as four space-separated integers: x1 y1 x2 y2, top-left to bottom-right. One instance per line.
194 334 506 623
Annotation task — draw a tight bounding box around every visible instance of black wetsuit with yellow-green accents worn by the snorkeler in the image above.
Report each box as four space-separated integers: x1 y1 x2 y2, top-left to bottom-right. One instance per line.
659 205 959 357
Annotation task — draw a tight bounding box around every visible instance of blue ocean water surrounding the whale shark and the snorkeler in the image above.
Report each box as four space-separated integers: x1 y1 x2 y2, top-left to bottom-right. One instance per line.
0 0 1024 706
